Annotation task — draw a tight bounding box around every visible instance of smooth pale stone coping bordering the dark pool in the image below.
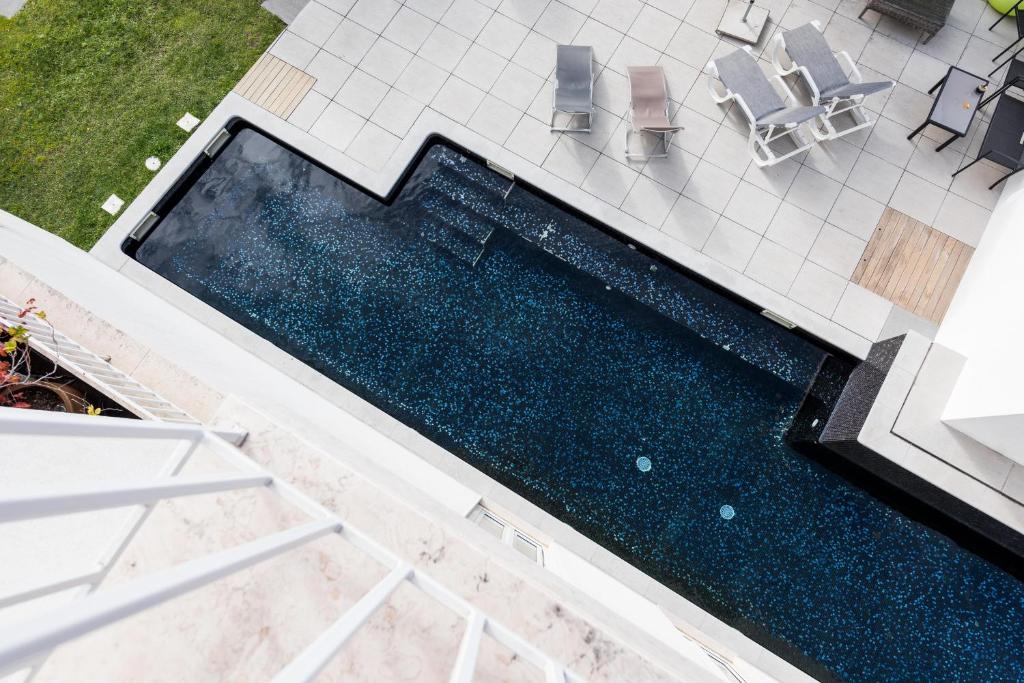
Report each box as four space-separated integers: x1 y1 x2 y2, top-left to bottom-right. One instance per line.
90 93 871 682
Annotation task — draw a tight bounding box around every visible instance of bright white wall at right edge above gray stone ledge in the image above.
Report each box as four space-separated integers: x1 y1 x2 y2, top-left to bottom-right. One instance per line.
935 176 1024 463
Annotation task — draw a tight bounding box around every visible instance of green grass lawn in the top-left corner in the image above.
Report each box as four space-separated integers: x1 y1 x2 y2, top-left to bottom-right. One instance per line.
0 0 284 249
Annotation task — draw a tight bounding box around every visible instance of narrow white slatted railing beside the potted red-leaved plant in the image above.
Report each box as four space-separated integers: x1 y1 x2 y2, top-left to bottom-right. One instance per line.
0 296 197 424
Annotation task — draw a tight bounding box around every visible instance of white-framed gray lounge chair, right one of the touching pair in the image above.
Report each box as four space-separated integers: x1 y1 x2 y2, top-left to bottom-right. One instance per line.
772 22 894 140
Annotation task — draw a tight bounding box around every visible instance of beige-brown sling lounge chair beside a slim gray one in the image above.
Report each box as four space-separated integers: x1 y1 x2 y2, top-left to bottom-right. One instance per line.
626 67 683 159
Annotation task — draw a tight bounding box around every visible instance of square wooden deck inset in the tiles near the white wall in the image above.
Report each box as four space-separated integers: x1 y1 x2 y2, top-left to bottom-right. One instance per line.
852 207 974 324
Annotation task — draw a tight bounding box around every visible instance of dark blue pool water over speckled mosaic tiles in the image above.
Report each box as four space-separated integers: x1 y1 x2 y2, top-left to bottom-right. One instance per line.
136 129 1024 681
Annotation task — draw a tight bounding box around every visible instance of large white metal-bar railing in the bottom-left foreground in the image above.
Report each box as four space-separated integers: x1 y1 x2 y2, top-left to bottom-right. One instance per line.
0 409 583 683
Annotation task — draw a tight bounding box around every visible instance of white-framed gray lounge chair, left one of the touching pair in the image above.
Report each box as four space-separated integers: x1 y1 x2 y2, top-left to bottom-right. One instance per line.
707 47 825 167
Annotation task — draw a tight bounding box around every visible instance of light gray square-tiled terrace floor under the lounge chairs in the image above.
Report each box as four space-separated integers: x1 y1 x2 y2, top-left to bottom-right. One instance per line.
260 0 1016 348
